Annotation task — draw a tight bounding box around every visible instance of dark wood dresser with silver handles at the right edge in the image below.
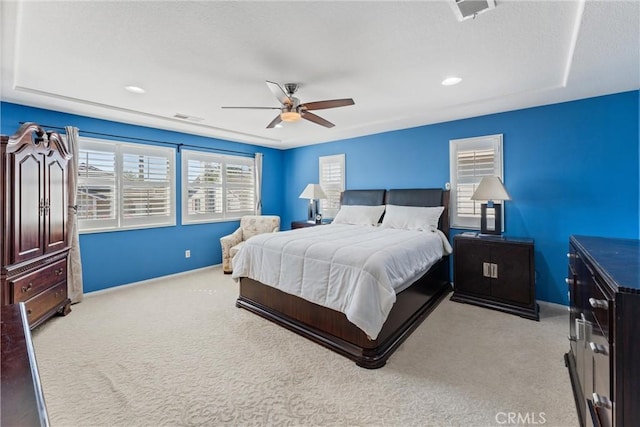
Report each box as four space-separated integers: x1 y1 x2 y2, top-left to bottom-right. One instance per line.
565 236 640 427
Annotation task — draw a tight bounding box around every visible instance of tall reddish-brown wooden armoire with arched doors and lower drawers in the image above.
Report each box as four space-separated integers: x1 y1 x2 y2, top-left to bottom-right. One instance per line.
0 123 71 328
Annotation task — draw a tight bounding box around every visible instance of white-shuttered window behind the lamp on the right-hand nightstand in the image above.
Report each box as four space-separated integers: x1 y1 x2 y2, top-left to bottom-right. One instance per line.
449 134 504 229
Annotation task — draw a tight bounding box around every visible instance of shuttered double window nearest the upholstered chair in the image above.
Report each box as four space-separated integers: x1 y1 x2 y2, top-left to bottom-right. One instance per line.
182 150 256 224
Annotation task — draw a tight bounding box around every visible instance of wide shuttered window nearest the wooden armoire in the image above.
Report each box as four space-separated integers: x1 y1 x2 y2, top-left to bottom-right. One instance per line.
77 138 176 232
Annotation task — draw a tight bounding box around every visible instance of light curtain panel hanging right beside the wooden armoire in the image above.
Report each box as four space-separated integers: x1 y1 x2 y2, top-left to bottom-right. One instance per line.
64 126 83 304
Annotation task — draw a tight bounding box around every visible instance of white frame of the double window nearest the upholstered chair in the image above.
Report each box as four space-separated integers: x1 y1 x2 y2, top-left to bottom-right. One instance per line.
181 149 258 225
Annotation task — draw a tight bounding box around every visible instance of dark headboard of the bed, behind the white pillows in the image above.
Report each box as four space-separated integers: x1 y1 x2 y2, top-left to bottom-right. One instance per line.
340 188 450 237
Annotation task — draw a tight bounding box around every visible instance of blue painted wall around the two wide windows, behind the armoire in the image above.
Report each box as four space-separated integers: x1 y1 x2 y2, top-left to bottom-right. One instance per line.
0 102 285 292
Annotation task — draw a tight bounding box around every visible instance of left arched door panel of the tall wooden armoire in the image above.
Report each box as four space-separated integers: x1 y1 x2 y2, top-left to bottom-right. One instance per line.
12 151 44 262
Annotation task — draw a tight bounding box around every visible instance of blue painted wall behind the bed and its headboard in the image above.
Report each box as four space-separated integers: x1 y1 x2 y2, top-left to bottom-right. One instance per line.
283 91 640 304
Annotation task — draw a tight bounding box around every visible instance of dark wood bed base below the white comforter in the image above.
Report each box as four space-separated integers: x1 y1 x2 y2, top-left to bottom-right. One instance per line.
236 256 451 369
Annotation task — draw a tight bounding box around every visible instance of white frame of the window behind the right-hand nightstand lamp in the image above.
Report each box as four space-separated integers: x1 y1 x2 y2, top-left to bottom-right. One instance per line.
449 134 504 231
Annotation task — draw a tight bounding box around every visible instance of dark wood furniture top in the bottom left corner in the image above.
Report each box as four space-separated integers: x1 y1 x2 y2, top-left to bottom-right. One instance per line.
0 303 49 427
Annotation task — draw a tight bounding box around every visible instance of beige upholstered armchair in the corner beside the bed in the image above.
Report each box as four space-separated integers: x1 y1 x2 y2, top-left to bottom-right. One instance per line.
220 215 280 274
